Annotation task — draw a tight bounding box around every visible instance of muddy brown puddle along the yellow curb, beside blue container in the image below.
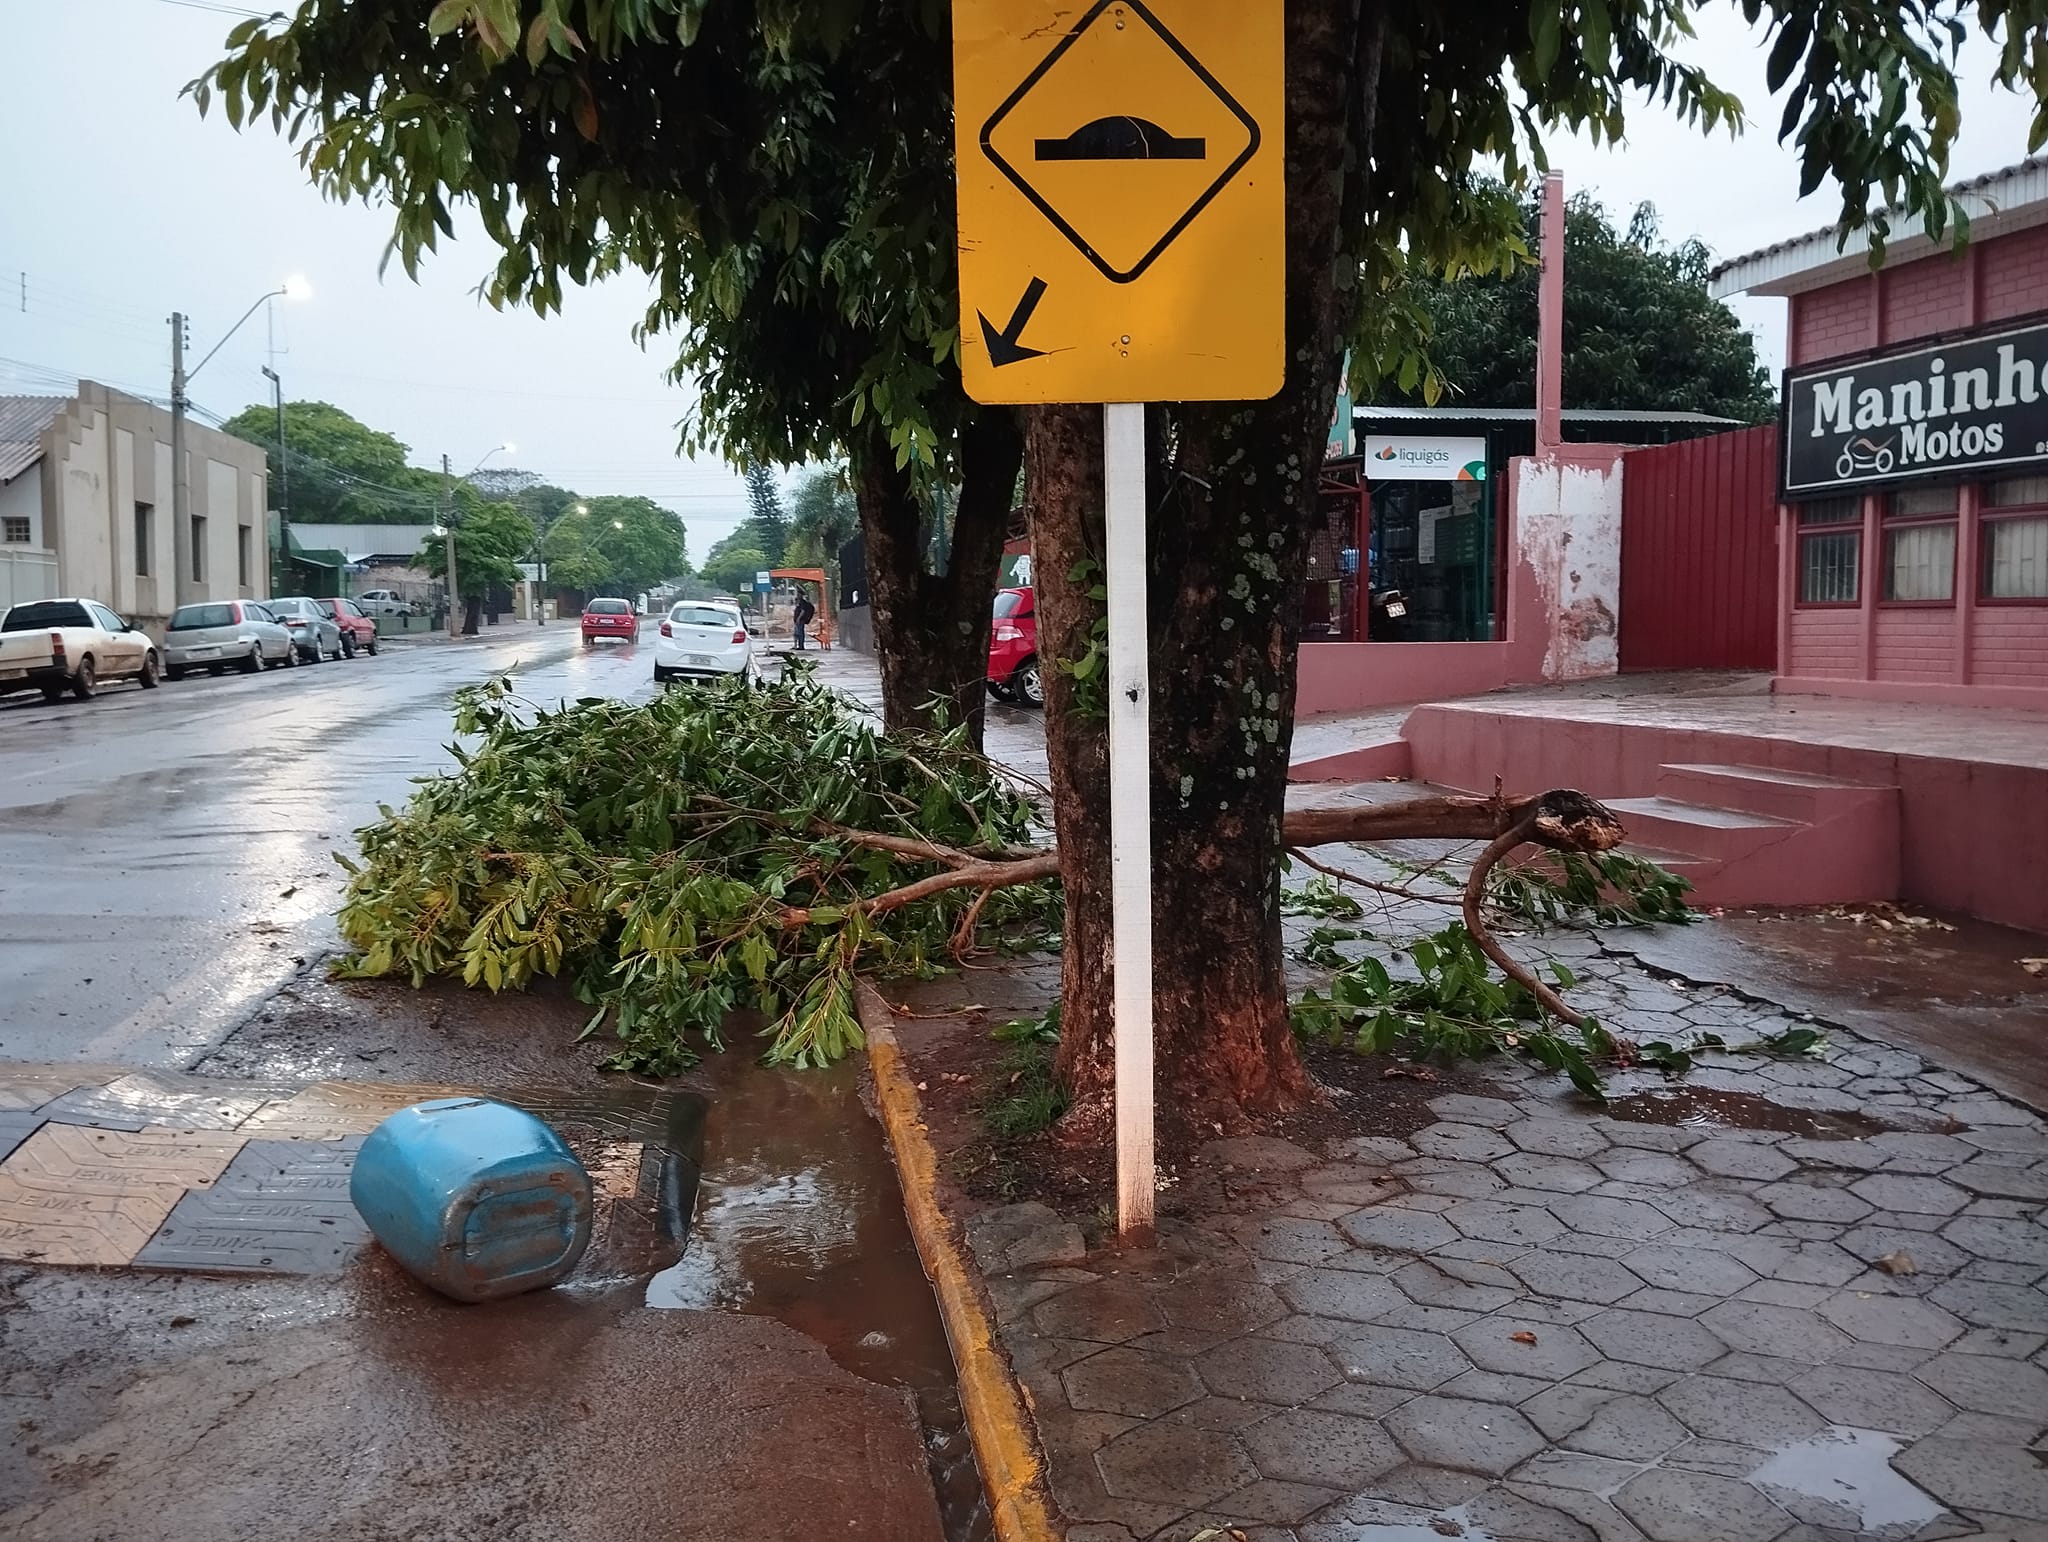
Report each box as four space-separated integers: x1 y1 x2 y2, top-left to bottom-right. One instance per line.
647 1053 991 1542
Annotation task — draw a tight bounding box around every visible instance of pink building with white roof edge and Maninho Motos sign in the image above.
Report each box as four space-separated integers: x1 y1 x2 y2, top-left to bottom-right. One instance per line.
1714 158 2048 706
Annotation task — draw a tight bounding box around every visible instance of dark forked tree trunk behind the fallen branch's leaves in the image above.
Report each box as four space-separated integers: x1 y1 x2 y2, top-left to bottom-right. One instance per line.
854 408 1024 747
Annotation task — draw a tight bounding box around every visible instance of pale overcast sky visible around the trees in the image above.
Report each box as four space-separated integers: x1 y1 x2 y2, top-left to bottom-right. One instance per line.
0 0 2030 559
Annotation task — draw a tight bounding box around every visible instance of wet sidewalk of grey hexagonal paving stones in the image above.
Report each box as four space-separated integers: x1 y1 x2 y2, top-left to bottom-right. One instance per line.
969 969 2048 1542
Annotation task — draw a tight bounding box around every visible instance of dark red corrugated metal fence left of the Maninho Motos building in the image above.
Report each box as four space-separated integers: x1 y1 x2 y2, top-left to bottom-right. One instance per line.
1620 426 1778 670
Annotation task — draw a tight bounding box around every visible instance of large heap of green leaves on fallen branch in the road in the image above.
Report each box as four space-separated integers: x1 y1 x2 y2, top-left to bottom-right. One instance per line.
338 668 1059 1073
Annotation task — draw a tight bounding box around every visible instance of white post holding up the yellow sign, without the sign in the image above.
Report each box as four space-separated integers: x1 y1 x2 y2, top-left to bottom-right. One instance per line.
1102 401 1157 1237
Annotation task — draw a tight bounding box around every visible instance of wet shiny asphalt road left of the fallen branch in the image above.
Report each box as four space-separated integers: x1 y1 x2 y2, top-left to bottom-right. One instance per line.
0 625 653 1067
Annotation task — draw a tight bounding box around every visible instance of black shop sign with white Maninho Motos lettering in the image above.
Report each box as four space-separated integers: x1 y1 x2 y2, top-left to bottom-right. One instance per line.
1784 322 2048 498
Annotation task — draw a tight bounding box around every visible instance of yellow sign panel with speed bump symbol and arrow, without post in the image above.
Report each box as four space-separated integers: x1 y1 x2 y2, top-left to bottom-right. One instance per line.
952 0 1286 401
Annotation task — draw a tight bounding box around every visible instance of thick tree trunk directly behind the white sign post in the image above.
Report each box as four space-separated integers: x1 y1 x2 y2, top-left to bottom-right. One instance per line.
1026 0 1376 1141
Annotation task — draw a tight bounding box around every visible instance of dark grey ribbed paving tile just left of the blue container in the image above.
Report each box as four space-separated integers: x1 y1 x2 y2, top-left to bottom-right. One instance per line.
135 1137 371 1274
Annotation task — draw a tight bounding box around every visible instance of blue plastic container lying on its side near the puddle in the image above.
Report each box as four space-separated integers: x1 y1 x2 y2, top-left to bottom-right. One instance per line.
348 1098 590 1300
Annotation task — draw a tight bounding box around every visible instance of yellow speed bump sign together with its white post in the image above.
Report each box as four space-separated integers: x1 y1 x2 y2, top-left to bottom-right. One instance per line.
952 0 1286 1239
